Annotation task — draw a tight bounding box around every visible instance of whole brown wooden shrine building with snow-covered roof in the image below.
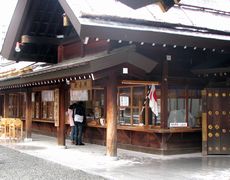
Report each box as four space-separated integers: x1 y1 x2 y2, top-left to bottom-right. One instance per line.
0 0 230 156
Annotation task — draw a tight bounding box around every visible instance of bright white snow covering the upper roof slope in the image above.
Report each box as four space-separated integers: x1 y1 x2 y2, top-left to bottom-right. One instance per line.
67 0 230 32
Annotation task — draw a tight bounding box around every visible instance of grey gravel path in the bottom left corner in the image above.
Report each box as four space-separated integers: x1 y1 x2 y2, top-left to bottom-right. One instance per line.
0 146 104 180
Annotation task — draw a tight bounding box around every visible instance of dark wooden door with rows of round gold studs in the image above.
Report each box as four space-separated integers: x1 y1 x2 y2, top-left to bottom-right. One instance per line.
207 88 230 154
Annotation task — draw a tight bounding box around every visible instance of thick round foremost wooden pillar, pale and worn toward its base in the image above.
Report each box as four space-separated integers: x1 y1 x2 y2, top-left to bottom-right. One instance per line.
106 73 117 157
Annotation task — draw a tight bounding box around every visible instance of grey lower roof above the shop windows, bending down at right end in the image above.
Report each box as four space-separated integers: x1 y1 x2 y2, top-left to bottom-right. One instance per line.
0 46 156 87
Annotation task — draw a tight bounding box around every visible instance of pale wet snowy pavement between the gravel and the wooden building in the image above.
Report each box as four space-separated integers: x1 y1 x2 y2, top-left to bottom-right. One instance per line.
2 134 230 180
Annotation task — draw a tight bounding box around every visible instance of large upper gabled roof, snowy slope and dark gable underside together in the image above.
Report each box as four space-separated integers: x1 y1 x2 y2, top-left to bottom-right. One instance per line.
2 0 230 63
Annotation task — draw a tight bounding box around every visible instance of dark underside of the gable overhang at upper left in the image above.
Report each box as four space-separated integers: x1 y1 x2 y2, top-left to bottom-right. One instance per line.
1 0 76 63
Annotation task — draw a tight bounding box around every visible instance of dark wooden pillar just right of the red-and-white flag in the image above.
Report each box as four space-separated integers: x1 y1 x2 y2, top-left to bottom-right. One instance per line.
161 61 168 128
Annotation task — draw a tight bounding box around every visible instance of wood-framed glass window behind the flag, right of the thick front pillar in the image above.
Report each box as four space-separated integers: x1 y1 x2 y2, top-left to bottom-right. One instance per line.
118 85 160 126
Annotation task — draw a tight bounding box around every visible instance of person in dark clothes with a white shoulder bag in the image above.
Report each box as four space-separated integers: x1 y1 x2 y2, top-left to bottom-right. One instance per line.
73 101 86 145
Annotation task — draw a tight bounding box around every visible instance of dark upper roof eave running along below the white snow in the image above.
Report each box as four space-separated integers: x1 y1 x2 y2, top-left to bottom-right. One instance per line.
78 17 230 52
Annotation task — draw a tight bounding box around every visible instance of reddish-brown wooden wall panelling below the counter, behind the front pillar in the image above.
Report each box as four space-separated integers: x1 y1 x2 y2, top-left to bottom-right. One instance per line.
84 127 201 154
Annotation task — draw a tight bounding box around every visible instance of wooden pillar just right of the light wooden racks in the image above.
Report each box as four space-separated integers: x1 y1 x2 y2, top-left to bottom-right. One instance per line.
25 90 32 139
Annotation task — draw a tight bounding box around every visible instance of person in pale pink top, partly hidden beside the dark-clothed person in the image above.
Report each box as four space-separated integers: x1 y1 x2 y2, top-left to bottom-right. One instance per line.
68 103 76 144
